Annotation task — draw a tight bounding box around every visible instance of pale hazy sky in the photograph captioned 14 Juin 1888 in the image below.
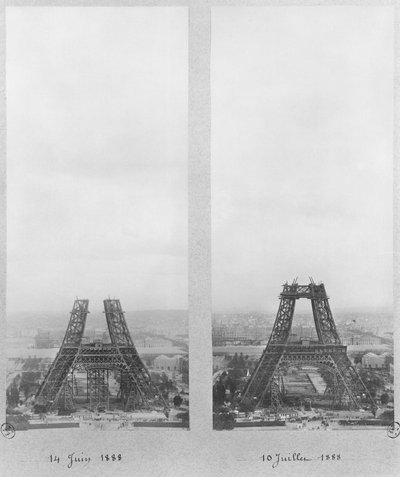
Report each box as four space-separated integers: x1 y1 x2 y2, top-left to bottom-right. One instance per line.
7 7 188 312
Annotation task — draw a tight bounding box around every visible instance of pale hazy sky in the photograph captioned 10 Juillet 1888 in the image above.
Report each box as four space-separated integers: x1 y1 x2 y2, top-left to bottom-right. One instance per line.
211 7 394 311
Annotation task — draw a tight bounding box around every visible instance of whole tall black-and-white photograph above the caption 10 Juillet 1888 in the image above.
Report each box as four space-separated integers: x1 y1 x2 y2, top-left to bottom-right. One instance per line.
211 6 394 431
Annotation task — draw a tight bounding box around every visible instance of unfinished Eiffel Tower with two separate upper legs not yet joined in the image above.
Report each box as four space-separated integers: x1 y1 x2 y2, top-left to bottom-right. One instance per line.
35 299 168 412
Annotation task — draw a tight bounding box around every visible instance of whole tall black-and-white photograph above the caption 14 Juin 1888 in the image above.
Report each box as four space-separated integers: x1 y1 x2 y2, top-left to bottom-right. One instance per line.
6 7 189 432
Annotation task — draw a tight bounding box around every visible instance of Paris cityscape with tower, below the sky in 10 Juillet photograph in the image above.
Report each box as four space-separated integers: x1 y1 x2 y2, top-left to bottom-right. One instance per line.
212 283 394 430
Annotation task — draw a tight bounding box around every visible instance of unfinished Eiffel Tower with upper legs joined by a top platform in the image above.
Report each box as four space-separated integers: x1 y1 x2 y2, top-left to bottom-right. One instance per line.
239 279 377 414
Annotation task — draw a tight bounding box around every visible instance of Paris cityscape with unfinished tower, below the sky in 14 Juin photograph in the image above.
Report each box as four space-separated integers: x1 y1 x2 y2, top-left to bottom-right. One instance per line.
6 300 189 430
